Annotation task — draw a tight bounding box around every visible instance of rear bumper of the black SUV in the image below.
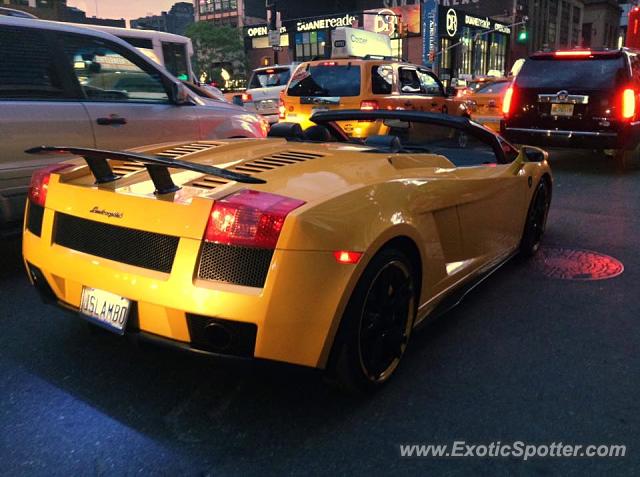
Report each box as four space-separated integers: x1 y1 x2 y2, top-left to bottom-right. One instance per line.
500 121 640 149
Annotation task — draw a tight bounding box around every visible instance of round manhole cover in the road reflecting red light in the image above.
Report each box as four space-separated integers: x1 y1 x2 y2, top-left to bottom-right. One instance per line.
535 247 624 280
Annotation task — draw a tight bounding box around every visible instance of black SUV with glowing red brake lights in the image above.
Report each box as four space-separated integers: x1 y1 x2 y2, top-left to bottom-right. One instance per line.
501 48 640 167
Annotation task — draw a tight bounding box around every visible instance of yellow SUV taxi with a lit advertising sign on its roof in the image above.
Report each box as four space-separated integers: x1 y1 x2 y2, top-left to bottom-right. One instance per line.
279 28 469 138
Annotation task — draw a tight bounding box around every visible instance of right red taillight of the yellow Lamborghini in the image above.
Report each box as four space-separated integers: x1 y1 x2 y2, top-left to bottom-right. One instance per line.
204 190 305 249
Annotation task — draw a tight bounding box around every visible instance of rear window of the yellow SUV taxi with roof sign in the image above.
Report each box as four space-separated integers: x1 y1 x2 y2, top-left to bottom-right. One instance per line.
287 65 360 96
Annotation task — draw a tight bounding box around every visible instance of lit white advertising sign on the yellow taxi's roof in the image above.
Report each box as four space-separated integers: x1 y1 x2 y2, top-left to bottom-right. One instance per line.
331 27 391 58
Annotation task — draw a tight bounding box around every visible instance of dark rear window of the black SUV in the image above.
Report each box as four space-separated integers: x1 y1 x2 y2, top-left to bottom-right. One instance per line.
516 57 625 89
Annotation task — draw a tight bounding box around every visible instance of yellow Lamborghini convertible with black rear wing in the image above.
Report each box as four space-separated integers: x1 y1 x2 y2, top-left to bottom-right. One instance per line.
23 111 552 390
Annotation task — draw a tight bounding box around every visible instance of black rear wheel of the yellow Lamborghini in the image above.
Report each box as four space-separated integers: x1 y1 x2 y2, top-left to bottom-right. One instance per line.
327 248 417 393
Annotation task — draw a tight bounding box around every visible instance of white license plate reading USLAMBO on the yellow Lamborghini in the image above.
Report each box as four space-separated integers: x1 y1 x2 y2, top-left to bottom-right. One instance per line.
80 287 131 335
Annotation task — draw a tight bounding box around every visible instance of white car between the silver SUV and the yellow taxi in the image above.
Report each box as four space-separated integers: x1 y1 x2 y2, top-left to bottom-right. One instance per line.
241 64 296 124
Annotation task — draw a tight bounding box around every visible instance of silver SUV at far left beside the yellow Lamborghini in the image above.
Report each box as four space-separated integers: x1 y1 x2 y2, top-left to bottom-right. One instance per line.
0 16 268 224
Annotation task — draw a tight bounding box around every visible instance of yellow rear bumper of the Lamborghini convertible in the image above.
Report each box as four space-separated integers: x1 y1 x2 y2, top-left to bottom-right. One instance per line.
23 213 354 368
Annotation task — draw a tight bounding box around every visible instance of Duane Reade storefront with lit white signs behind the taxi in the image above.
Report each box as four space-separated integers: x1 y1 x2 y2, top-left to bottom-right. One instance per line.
243 2 511 81
